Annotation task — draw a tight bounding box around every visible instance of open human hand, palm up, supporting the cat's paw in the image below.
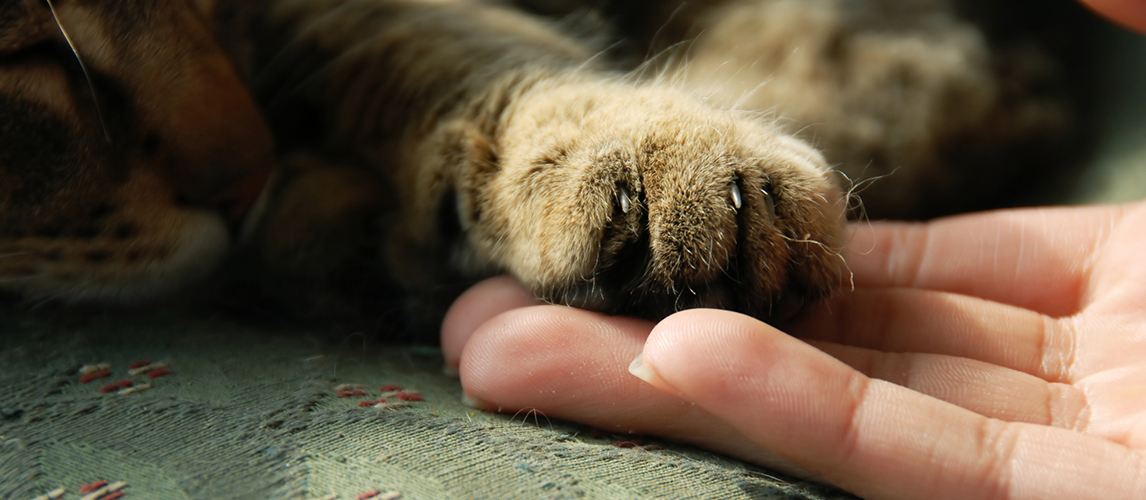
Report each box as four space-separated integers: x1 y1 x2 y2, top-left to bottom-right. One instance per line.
442 203 1146 499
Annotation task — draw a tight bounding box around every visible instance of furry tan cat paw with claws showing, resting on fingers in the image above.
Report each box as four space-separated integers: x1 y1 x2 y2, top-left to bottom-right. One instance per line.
457 83 845 319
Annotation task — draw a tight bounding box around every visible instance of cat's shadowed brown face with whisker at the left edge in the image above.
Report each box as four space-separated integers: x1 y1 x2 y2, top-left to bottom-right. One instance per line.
0 0 274 303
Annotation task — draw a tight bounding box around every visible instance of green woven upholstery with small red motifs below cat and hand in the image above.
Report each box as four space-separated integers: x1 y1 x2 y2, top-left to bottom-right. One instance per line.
0 311 848 500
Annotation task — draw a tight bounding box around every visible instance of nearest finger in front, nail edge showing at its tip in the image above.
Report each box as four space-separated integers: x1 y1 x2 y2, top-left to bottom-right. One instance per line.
637 310 1146 499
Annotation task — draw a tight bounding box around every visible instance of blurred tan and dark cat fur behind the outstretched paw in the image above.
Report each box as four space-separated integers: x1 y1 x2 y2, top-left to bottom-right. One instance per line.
517 0 1072 220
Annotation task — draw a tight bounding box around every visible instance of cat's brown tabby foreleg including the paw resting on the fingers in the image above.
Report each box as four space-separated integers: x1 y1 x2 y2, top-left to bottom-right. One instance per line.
255 0 843 318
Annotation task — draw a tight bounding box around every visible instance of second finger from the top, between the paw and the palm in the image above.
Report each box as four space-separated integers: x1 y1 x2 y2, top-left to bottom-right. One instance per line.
784 289 1074 382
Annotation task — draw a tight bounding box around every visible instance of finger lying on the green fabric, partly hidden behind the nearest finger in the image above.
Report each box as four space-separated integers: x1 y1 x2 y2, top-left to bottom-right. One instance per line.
460 306 808 477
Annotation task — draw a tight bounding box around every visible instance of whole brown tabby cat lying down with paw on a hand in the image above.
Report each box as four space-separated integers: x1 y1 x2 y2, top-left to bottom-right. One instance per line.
0 0 1061 321
